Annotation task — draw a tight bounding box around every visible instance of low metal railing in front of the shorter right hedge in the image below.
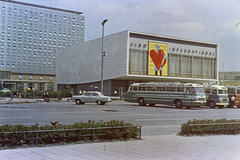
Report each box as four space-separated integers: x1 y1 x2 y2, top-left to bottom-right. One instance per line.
188 123 240 137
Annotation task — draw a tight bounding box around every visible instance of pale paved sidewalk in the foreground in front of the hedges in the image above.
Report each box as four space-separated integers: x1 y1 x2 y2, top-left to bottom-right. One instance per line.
0 135 240 160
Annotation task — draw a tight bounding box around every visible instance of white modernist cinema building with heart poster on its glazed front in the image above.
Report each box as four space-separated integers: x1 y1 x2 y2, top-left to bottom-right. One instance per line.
56 31 219 96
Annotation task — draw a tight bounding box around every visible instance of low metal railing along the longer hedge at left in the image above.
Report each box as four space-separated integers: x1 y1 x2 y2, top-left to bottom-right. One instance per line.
0 126 142 145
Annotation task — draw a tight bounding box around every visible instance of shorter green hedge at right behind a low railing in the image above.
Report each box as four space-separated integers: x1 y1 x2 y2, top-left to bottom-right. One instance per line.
178 118 240 135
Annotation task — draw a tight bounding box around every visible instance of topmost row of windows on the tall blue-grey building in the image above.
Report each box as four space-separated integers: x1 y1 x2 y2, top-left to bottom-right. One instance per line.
2 7 84 23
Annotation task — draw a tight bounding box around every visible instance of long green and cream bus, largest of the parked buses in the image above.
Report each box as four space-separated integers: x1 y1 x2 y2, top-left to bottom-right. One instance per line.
124 82 206 109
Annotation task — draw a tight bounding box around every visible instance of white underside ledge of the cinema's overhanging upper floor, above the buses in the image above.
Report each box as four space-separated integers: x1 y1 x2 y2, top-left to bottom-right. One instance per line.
113 74 217 84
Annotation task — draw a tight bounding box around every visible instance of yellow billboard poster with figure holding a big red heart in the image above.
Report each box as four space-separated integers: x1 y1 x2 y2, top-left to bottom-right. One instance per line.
148 42 168 76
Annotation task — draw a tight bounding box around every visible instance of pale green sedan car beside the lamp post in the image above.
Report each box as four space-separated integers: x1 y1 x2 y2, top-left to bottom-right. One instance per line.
72 91 112 105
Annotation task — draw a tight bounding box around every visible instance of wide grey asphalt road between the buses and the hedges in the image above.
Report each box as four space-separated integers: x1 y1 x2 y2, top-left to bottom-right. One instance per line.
0 101 240 136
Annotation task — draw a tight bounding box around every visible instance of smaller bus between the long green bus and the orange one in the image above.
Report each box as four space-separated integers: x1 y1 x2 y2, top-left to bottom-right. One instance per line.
204 85 228 109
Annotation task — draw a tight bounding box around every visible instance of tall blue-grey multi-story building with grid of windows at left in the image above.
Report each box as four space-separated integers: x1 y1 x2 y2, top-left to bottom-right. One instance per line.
0 0 85 91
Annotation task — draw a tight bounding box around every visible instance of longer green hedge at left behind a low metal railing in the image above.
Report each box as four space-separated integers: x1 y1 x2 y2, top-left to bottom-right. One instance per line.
0 120 141 149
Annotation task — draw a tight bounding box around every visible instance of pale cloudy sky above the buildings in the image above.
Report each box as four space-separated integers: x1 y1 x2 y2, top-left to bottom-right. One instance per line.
17 0 240 71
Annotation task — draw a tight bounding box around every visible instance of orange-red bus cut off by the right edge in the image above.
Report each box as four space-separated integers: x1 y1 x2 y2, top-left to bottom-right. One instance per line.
227 86 240 108
